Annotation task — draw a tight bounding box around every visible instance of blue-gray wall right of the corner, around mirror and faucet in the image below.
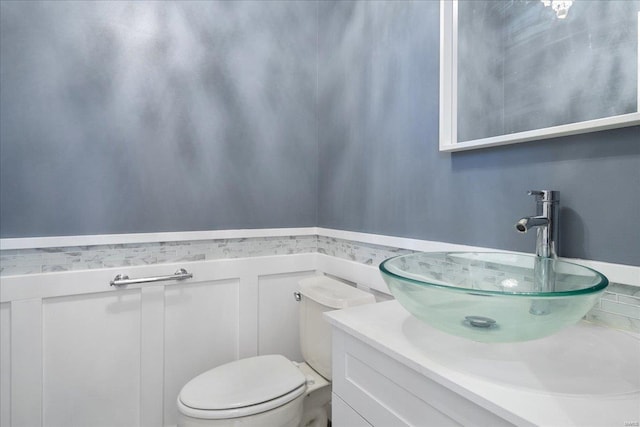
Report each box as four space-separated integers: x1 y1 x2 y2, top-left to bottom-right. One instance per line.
318 1 640 265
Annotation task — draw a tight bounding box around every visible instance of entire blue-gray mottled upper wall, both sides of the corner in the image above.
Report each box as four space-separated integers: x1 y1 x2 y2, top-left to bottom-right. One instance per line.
0 1 640 265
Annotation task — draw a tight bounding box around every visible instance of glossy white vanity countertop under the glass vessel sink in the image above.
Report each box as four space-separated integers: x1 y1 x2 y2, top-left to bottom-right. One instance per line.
325 301 640 427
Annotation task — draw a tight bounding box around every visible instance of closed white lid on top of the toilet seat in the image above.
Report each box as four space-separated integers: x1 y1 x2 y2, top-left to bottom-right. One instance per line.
179 354 306 410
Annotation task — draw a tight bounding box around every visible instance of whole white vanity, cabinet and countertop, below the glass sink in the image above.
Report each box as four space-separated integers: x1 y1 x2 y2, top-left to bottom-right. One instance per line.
325 301 640 427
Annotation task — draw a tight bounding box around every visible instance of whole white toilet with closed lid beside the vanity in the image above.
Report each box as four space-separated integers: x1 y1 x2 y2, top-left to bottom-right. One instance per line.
178 276 375 427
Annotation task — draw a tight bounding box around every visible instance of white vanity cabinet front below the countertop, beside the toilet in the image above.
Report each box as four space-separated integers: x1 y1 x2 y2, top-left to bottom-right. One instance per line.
332 328 513 427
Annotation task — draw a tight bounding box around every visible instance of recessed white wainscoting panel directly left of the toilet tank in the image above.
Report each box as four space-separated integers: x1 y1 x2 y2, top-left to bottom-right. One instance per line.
258 271 316 362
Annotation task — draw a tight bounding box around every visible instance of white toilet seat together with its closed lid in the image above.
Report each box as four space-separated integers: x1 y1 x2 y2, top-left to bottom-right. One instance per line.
178 355 306 419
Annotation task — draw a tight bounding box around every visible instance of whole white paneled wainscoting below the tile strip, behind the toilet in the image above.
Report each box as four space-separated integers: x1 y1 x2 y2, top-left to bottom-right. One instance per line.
0 253 368 427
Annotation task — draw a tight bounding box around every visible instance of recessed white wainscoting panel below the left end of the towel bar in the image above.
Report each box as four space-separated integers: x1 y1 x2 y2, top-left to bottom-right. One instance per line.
42 289 141 427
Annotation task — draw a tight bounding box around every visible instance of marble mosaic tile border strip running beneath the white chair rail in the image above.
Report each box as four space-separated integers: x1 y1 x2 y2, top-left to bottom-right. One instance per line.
0 235 640 333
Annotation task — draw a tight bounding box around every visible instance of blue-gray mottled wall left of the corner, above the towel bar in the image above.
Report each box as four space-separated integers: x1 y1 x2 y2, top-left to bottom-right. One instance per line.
0 1 318 237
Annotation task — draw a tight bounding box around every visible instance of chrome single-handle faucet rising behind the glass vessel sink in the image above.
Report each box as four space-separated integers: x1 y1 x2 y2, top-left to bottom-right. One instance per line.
516 190 560 259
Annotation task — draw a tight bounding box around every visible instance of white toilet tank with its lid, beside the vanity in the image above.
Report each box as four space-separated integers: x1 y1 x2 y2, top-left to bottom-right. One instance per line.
298 276 376 380
